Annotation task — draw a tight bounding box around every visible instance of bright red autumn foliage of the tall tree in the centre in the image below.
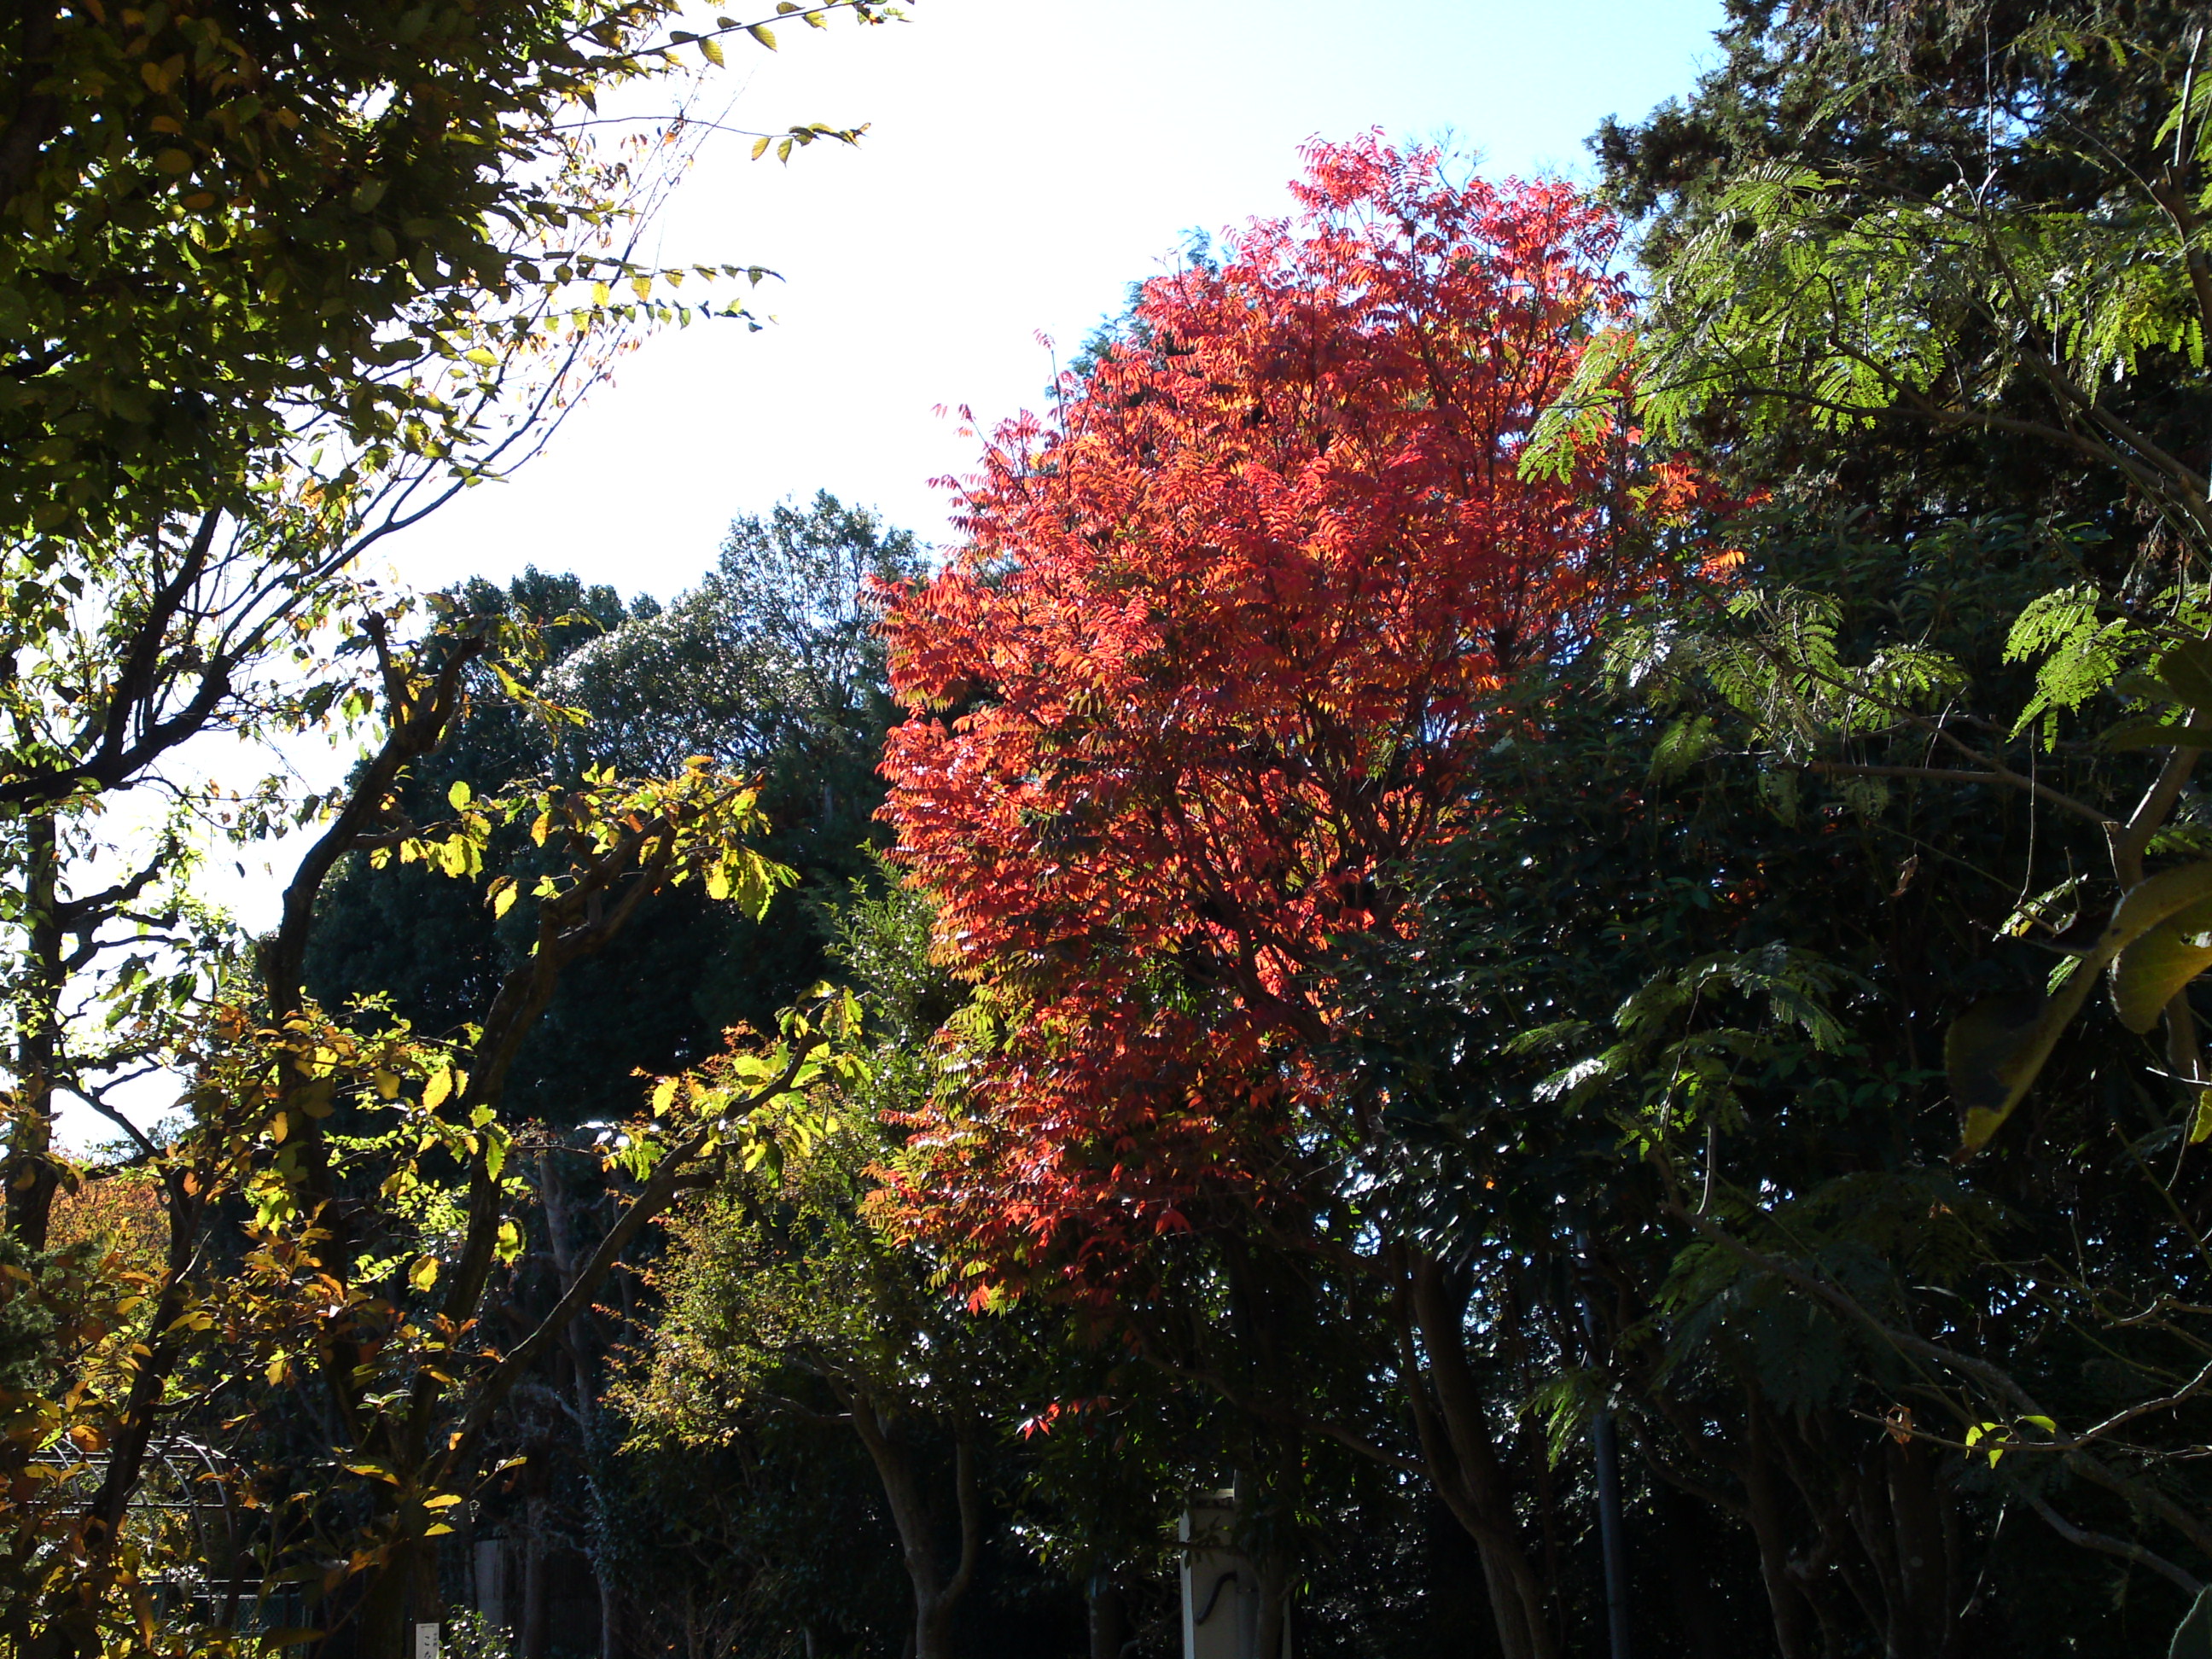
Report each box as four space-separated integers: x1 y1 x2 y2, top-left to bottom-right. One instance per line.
885 137 1690 1301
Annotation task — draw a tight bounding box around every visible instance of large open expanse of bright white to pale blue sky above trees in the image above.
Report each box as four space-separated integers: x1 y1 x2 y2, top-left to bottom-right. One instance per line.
387 0 1721 597
